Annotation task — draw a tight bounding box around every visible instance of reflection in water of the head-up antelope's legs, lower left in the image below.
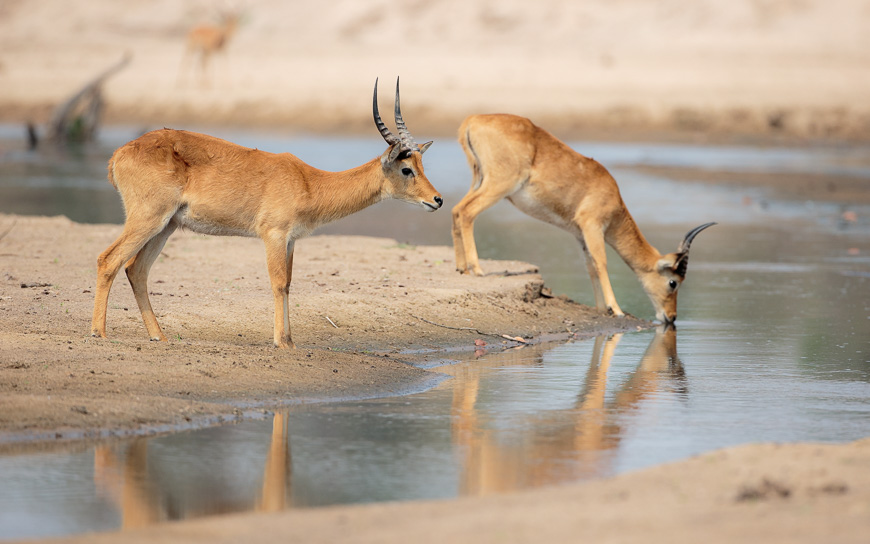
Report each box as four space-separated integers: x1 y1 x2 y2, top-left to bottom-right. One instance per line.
94 413 292 529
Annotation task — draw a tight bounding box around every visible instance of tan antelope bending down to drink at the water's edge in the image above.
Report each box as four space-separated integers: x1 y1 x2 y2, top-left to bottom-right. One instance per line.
453 114 715 324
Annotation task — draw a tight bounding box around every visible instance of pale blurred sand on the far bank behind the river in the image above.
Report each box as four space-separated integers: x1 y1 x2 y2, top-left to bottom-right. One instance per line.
0 0 870 139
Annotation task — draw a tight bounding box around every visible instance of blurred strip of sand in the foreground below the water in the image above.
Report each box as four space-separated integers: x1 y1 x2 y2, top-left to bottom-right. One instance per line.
37 440 870 544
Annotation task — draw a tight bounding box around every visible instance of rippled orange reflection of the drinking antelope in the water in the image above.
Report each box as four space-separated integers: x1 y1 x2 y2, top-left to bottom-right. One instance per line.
445 327 687 496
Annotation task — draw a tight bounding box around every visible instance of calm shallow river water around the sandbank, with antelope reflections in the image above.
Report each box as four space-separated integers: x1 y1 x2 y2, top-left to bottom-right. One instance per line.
0 127 870 538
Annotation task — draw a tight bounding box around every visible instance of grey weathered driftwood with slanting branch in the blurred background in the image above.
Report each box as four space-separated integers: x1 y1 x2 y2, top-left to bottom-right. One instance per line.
28 53 131 148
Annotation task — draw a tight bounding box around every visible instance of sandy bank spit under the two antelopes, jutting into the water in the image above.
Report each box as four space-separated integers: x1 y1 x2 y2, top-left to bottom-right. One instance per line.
0 215 646 449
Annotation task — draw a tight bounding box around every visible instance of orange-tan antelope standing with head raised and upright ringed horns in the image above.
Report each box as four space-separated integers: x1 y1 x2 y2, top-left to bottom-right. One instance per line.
91 80 442 348
